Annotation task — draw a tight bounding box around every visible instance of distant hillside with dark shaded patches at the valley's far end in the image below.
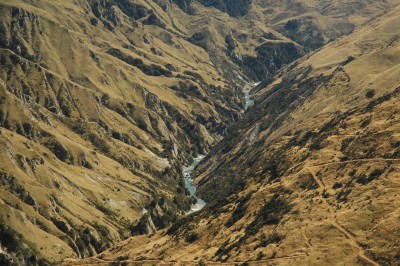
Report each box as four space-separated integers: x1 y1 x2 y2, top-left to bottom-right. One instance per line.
180 0 398 81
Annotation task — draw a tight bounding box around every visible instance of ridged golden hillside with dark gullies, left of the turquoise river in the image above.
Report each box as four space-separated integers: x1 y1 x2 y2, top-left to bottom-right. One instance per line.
0 1 244 264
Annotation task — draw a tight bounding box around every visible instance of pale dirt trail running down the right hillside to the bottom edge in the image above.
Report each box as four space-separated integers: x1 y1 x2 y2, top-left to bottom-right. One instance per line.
306 166 380 266
